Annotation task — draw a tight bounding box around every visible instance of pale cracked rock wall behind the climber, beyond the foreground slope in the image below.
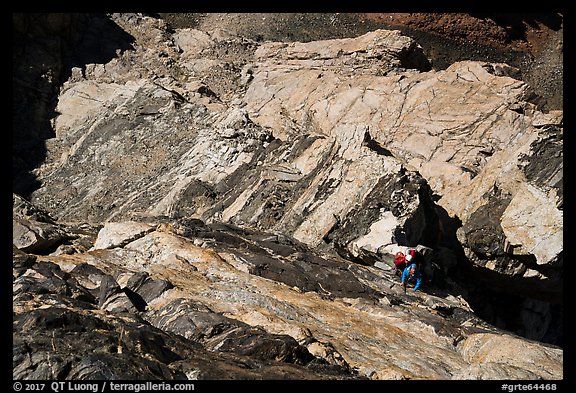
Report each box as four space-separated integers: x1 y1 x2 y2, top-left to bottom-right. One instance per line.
15 15 562 378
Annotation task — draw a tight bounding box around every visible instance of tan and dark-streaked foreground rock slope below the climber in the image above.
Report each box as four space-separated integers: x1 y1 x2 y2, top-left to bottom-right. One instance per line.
13 217 563 379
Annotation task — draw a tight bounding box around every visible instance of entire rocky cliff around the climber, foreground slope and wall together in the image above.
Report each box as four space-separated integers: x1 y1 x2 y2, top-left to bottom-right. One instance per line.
13 14 563 379
